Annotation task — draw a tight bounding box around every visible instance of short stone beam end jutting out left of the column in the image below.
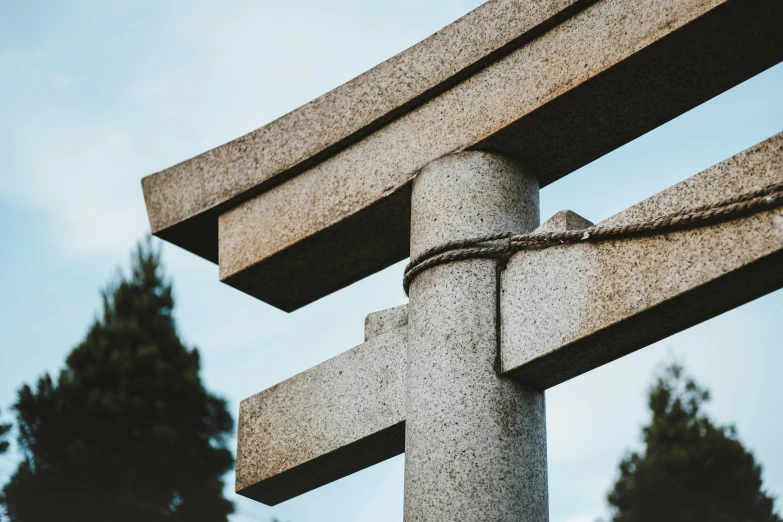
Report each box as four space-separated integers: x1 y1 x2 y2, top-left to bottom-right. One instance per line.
236 327 407 505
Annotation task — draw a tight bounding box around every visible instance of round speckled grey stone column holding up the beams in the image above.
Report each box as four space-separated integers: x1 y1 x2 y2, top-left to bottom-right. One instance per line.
405 152 549 522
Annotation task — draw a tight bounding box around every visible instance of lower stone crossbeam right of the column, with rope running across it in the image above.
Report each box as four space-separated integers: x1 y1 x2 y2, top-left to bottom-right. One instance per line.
501 134 783 390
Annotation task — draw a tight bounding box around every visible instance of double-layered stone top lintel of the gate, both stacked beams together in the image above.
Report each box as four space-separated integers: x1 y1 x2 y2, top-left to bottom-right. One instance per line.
143 0 783 311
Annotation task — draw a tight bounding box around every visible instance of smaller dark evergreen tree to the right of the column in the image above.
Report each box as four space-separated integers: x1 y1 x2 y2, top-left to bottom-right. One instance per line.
608 364 781 522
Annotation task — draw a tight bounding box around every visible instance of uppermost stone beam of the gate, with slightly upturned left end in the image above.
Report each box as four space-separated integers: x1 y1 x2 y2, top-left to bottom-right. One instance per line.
143 0 593 261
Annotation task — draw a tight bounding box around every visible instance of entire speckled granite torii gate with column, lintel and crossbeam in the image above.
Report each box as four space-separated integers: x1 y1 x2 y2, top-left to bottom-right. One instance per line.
143 0 783 522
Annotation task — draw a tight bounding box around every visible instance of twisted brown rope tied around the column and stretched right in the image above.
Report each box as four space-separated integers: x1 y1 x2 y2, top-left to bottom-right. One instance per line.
402 183 783 295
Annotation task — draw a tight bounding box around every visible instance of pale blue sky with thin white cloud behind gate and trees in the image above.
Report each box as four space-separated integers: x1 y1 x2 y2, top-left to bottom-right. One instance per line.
0 0 783 522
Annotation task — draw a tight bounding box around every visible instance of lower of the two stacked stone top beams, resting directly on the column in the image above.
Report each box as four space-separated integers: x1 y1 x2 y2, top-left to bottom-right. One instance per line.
217 0 783 311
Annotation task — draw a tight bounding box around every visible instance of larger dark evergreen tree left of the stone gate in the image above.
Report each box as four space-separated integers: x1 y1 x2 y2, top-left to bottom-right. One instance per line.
0 238 233 522
